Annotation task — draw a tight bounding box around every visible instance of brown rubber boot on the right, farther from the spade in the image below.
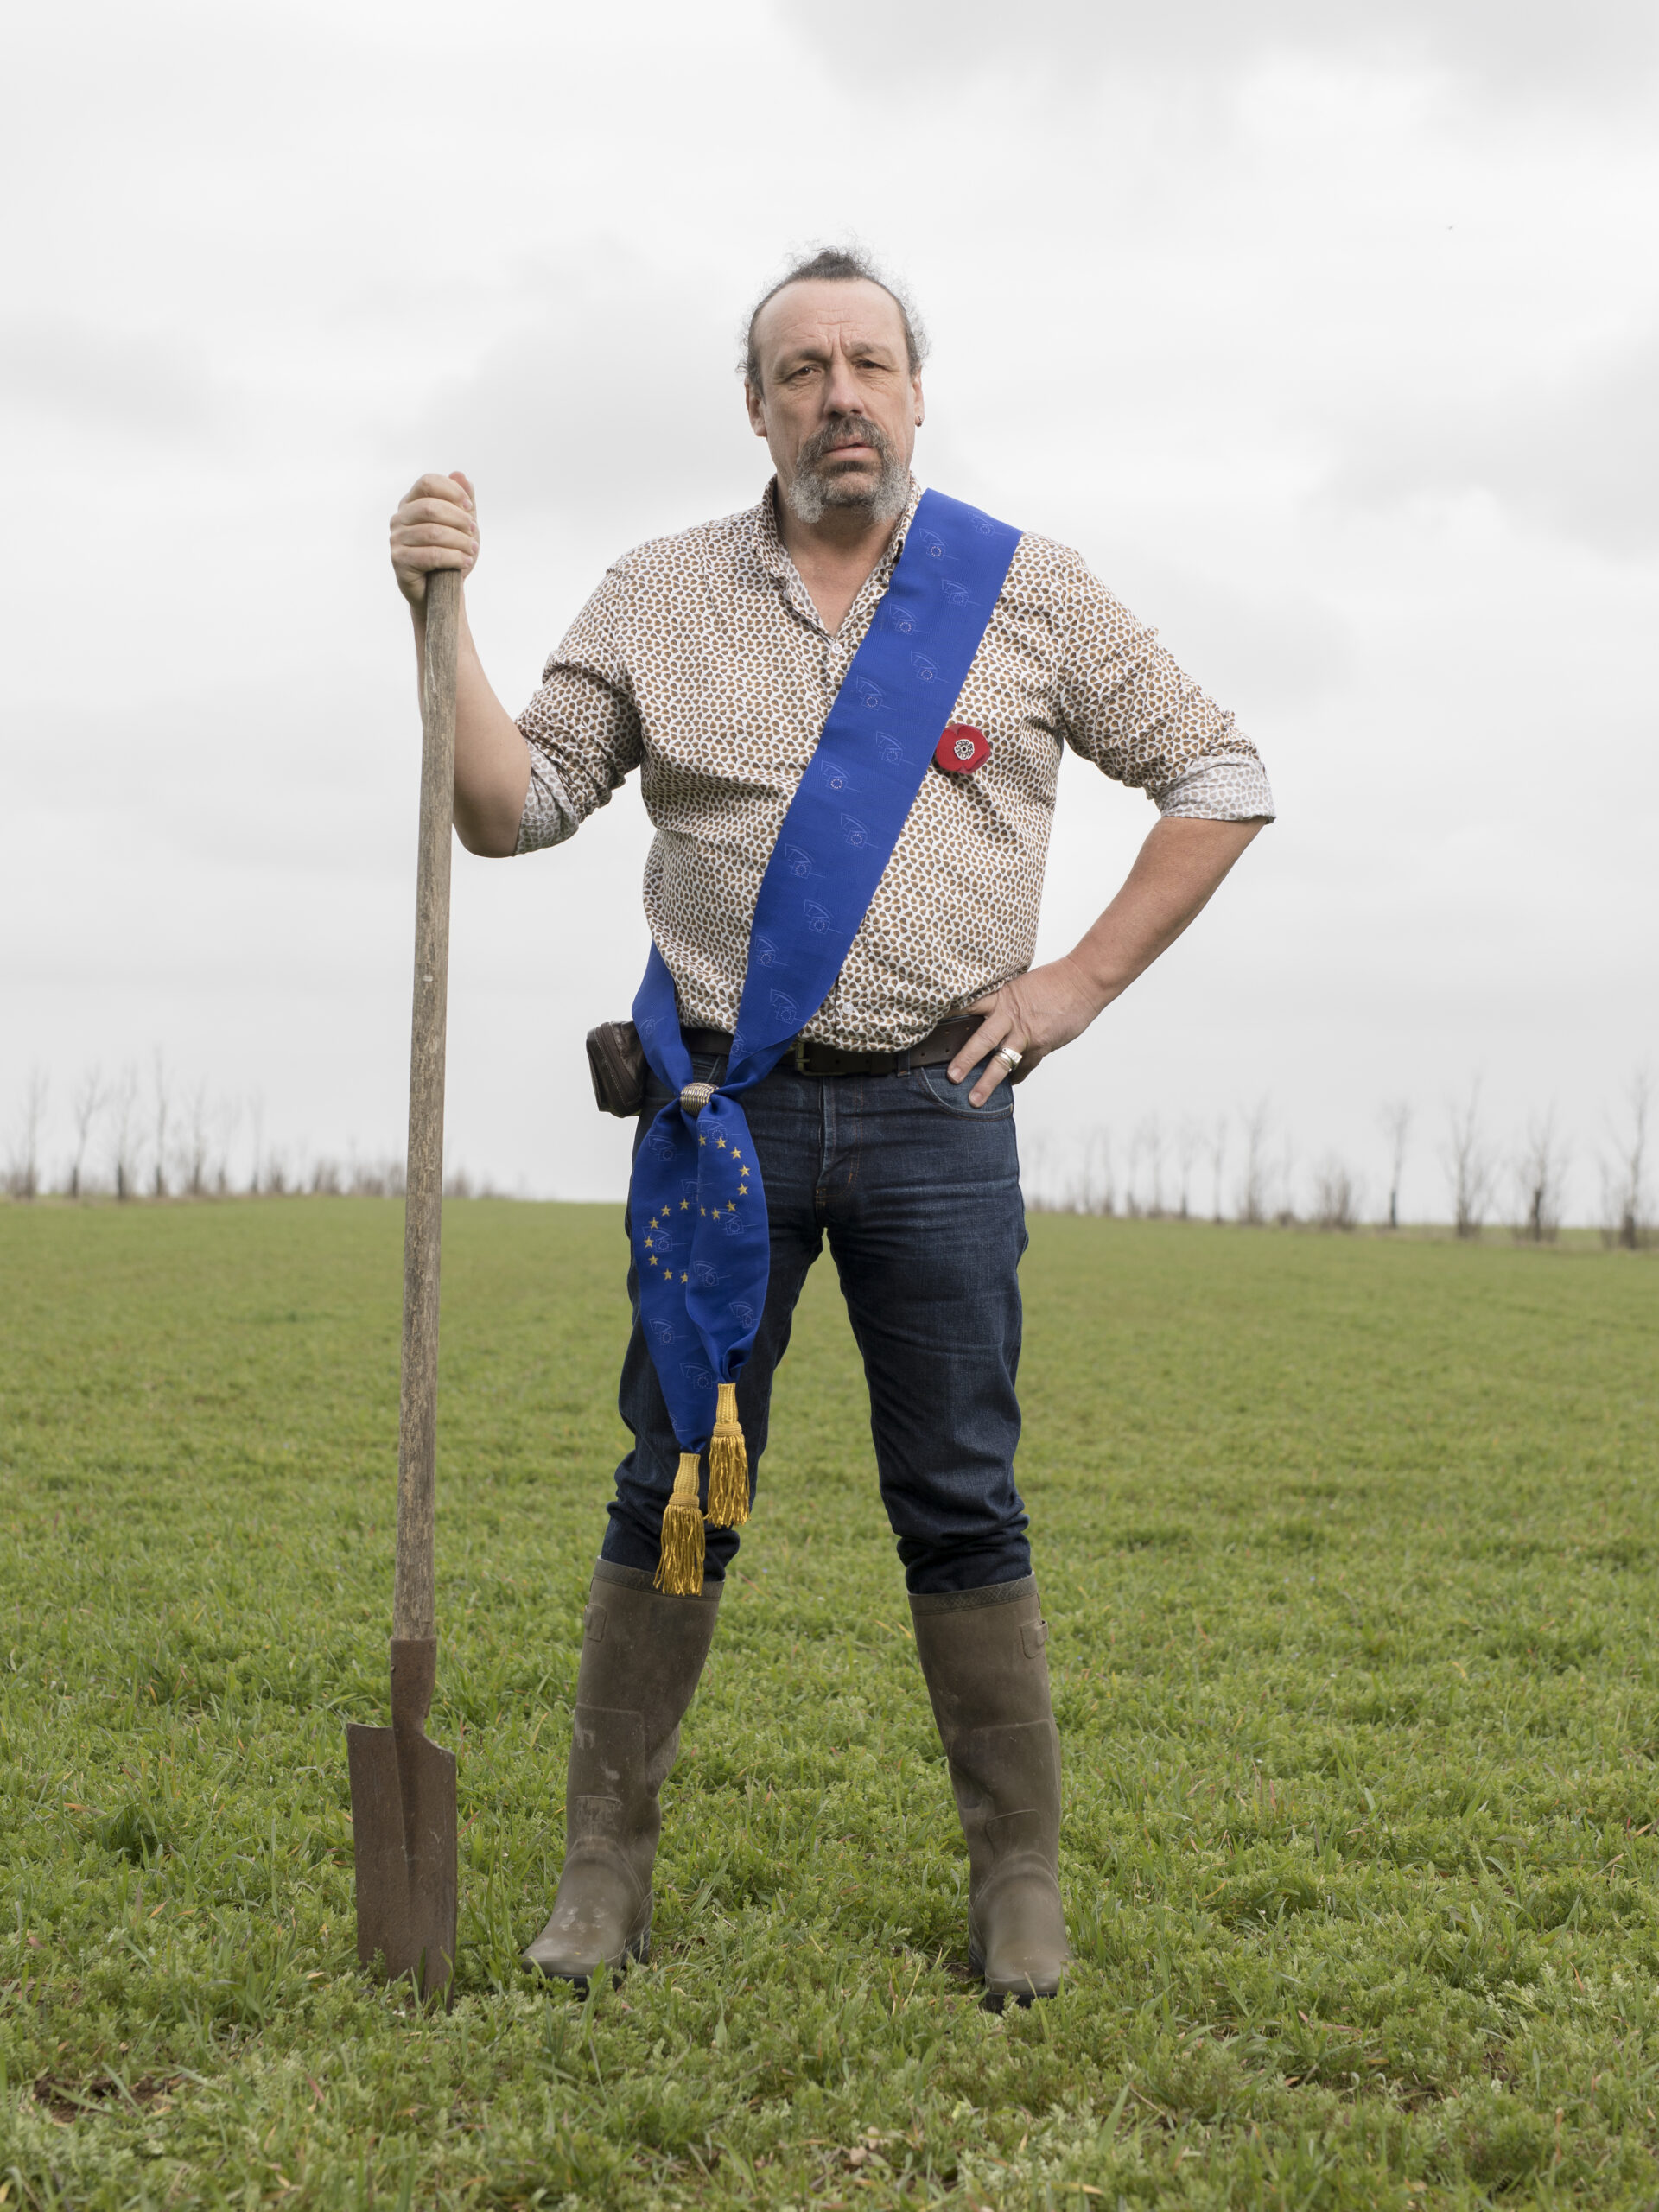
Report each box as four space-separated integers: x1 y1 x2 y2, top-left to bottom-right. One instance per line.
909 1575 1071 2004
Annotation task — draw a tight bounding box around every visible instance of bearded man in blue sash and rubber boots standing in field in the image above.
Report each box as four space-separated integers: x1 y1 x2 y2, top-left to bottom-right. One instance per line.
391 252 1272 2002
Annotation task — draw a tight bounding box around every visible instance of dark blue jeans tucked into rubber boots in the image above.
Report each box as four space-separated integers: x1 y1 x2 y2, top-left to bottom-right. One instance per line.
601 1058 1031 1592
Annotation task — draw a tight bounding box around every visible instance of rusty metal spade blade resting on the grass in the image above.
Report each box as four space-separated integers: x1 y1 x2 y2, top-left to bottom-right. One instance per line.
345 1637 455 1999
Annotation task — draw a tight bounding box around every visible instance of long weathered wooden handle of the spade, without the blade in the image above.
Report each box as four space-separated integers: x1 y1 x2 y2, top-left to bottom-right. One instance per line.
391 569 460 1642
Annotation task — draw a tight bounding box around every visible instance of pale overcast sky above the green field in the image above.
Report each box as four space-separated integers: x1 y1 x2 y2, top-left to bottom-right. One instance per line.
0 0 1659 1217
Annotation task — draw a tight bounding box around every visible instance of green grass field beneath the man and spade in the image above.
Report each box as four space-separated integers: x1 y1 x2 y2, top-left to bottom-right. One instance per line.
0 1201 1659 2212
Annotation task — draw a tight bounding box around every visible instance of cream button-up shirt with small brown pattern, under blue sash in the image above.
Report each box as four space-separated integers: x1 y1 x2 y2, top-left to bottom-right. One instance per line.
518 480 1274 1051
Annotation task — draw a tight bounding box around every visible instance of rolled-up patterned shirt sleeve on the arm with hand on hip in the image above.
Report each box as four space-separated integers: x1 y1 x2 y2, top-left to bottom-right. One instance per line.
1055 553 1274 821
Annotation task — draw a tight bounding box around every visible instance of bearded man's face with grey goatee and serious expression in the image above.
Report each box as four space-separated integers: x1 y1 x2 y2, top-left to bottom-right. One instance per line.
743 283 923 522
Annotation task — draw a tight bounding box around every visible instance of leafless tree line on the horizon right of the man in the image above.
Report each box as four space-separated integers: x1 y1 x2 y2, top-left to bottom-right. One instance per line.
1024 1071 1655 1249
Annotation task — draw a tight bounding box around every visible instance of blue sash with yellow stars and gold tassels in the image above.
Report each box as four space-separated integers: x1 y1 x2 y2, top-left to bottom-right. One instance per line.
628 491 1020 1592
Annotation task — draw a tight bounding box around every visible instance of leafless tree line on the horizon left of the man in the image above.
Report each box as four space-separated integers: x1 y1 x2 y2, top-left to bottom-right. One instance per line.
0 1051 493 1201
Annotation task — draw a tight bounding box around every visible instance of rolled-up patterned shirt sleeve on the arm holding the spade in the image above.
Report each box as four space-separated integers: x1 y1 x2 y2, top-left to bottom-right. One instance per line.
515 562 641 852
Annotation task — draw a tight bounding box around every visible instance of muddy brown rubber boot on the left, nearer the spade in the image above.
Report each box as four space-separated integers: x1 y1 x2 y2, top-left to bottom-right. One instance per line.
524 1560 721 1988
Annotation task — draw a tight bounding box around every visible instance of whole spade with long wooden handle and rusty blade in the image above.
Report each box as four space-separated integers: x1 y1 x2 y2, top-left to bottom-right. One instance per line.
345 569 460 2004
